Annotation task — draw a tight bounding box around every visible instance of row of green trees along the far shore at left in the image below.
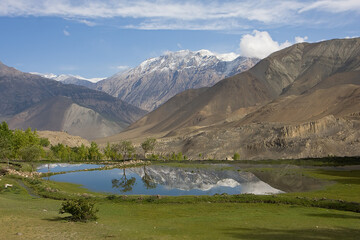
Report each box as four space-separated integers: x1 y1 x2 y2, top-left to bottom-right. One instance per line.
0 122 186 161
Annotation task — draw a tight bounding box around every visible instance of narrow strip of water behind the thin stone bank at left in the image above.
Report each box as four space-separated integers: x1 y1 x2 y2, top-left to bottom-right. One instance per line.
37 163 104 173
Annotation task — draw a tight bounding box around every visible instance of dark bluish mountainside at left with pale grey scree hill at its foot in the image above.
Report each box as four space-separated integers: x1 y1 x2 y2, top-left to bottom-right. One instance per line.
0 63 146 139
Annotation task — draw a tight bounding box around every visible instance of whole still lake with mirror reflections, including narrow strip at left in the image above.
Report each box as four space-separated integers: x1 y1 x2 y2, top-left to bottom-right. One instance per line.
37 164 324 196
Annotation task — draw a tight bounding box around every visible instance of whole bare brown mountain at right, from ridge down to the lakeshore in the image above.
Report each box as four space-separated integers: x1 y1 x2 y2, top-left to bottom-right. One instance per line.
100 38 360 159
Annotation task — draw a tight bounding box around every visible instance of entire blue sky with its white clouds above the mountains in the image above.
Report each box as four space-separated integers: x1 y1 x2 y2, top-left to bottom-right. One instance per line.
0 0 360 78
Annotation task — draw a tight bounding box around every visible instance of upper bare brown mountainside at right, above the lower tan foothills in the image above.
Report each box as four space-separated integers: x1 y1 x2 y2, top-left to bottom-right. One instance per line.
124 38 360 135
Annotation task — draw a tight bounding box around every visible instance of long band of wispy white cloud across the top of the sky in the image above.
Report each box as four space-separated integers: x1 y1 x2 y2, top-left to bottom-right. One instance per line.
0 0 360 30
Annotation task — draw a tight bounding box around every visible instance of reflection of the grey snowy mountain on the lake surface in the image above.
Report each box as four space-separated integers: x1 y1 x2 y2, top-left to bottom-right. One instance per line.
129 166 282 194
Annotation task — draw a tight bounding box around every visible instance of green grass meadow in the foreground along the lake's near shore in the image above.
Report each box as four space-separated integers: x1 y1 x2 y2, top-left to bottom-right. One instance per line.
0 162 360 240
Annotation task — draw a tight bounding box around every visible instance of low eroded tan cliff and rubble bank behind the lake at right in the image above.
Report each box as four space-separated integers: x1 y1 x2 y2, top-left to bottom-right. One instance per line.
157 116 360 159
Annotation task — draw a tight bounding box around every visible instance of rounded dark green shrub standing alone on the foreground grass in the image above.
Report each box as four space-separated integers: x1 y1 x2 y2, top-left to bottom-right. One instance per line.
59 199 99 222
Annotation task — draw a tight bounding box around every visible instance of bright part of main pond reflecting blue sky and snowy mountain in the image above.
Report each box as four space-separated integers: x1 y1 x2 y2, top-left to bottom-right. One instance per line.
43 166 281 196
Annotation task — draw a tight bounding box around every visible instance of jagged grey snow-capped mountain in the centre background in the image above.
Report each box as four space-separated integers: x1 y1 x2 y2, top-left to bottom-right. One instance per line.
96 50 259 111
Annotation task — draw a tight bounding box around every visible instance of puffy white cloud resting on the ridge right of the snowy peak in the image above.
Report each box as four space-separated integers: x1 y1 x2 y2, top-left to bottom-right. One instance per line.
240 30 291 58
